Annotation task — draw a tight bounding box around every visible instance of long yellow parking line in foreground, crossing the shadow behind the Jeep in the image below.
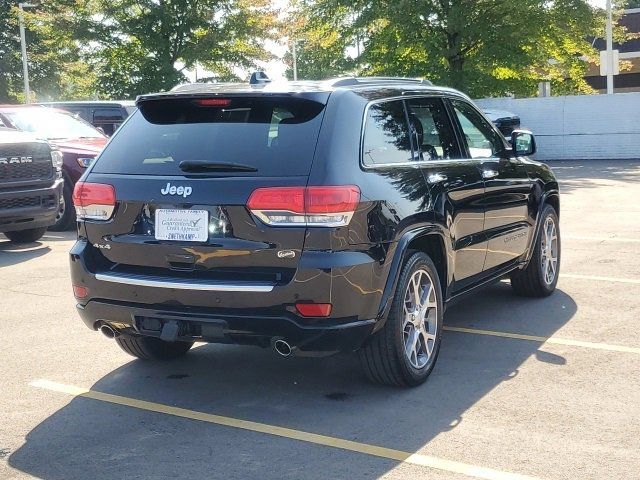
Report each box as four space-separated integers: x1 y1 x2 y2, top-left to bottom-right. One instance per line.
30 380 539 480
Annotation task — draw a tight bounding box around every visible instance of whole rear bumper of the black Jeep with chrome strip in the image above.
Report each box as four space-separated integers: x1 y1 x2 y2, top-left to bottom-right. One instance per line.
70 239 387 352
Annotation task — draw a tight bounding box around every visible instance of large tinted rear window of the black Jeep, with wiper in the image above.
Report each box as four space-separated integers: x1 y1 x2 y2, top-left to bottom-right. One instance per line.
93 97 324 176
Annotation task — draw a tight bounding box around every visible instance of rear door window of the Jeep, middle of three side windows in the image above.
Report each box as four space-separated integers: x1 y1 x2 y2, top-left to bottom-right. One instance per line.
406 98 461 160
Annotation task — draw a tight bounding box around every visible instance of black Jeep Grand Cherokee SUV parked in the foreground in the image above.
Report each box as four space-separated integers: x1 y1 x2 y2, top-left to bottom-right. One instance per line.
71 78 560 385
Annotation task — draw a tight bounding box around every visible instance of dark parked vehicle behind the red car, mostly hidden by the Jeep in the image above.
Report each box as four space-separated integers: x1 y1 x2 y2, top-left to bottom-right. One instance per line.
41 100 136 137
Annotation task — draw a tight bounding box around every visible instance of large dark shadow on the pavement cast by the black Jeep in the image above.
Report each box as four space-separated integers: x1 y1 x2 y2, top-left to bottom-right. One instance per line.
9 284 577 480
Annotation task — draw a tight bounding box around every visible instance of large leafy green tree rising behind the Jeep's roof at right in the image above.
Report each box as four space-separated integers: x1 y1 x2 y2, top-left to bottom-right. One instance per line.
305 0 603 96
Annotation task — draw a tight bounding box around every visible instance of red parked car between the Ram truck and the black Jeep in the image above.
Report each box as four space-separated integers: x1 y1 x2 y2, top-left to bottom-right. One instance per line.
0 105 107 230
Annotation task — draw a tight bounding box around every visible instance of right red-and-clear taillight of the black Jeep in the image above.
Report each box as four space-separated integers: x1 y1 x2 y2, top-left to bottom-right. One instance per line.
247 185 360 227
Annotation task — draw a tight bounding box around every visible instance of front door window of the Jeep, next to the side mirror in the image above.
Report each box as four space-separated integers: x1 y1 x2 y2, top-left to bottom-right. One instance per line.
451 100 504 158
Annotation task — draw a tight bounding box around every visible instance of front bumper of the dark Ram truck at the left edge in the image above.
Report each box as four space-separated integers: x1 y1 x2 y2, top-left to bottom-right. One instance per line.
0 179 63 232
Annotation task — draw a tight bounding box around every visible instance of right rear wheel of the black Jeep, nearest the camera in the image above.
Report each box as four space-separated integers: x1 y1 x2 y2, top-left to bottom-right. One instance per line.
358 252 443 387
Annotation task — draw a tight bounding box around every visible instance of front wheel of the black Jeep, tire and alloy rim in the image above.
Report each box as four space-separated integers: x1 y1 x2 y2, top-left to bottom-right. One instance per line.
511 205 561 297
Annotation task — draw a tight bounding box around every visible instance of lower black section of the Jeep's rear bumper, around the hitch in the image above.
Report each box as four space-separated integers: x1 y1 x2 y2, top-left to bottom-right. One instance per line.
77 300 375 353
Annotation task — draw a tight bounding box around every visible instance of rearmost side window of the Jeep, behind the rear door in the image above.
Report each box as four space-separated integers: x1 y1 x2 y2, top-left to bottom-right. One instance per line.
363 101 412 165
